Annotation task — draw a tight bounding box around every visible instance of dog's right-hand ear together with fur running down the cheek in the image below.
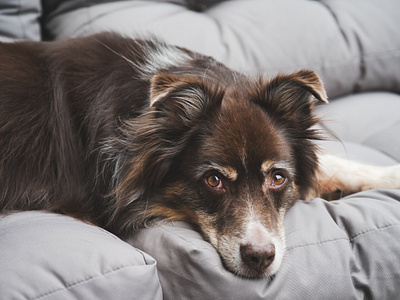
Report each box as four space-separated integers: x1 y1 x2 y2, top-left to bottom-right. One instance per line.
255 70 328 197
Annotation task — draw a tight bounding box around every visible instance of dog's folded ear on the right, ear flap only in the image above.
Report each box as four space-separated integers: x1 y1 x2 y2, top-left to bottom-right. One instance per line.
259 70 328 129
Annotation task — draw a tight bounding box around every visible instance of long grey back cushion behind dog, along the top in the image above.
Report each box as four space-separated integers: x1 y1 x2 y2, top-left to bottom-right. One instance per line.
44 0 400 98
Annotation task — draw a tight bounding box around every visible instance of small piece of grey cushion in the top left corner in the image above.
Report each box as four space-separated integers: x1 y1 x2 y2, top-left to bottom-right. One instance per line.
0 0 42 41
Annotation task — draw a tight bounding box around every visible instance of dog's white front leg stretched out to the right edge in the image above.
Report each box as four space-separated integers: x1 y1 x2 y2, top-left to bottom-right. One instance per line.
307 154 400 199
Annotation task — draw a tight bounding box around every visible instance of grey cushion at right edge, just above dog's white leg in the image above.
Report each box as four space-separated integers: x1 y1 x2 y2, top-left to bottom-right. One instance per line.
318 92 400 162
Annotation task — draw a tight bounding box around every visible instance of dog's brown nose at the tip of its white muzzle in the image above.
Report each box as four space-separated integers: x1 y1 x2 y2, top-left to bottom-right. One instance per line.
240 243 275 271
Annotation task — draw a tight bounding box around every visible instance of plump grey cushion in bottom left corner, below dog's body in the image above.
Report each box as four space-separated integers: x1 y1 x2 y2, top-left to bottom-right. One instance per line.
0 212 162 300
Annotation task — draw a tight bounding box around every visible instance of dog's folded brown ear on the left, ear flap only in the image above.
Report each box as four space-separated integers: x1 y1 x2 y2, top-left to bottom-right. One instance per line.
150 74 223 129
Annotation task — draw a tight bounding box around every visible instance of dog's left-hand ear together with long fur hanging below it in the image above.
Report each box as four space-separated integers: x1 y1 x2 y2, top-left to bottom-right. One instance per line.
108 74 223 232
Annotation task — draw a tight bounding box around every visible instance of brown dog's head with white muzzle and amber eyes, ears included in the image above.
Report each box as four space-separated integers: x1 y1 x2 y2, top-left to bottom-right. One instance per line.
111 71 326 277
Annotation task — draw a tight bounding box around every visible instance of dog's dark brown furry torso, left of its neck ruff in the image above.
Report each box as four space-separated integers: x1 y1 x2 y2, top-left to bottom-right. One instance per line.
0 35 150 214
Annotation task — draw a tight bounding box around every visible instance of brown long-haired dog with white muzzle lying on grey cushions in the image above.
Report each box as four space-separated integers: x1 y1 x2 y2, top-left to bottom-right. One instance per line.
0 33 400 278
